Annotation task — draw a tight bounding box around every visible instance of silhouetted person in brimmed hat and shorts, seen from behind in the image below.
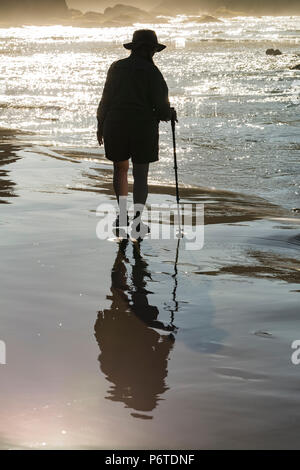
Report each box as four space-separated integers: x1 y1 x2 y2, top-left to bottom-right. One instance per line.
97 29 177 236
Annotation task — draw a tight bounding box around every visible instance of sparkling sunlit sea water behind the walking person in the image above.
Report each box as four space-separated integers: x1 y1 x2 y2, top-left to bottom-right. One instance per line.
0 17 300 210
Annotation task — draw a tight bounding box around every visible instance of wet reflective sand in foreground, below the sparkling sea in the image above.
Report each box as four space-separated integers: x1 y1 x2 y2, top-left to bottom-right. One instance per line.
0 130 300 449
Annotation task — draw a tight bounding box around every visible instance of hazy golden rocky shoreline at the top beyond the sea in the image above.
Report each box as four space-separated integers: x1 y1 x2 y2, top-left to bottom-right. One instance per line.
0 0 300 28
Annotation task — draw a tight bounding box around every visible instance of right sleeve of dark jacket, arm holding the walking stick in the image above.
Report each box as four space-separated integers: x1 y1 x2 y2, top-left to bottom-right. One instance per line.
150 67 171 121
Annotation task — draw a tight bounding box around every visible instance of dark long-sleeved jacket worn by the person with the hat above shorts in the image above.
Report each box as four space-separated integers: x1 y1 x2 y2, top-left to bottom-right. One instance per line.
97 54 171 132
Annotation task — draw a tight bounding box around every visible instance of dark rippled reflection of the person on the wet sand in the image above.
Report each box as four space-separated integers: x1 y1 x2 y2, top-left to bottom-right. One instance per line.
95 240 174 418
